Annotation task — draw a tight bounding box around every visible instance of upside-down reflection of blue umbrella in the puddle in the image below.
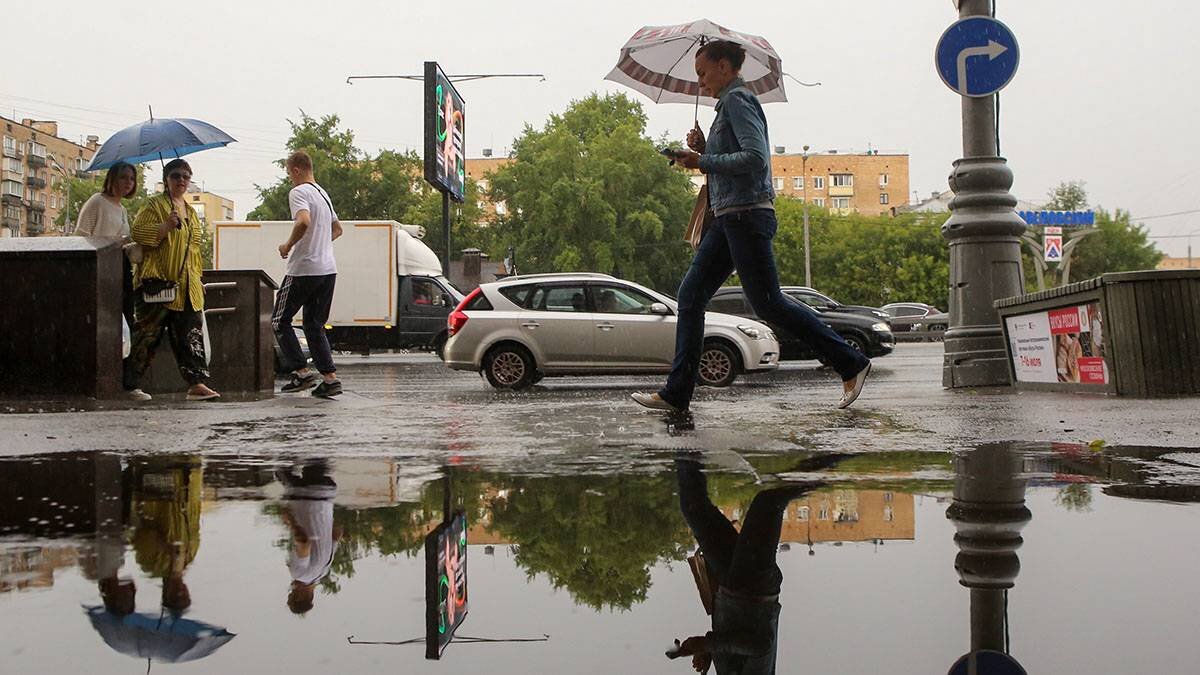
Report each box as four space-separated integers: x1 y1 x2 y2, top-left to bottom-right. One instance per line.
85 607 236 663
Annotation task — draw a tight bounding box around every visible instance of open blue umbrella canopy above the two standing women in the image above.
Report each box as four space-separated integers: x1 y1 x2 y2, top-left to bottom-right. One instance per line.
84 118 238 171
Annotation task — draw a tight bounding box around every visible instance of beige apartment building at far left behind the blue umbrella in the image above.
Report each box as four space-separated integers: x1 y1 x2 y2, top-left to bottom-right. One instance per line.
0 117 100 237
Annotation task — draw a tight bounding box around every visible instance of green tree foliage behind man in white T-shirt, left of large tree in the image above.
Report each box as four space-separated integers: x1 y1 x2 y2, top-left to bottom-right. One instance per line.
248 110 482 264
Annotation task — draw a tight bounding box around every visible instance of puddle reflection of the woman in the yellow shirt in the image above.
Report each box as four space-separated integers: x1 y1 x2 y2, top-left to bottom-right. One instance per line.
131 456 204 614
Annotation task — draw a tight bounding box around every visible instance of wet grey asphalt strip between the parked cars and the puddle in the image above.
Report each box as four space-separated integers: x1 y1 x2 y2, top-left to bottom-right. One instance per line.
0 344 1200 461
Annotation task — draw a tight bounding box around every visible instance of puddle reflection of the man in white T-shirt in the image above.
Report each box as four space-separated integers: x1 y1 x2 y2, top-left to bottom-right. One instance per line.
276 461 341 614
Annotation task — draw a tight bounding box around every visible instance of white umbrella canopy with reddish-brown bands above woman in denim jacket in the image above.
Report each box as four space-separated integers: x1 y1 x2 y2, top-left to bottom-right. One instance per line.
605 19 787 106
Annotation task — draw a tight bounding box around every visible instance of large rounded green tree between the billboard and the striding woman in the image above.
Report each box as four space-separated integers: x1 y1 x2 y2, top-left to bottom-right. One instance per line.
490 94 695 292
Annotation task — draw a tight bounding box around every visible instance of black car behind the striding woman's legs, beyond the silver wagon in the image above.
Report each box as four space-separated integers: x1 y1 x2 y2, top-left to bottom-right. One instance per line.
708 286 896 360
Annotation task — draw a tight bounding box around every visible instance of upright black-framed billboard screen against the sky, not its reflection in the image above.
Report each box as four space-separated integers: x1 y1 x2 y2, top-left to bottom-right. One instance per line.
425 61 467 202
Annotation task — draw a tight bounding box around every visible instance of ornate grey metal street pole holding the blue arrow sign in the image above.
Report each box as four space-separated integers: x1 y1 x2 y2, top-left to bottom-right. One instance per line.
942 0 1026 388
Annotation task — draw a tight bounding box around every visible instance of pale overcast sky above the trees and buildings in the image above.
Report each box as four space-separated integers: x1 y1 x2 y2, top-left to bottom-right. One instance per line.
9 0 1200 256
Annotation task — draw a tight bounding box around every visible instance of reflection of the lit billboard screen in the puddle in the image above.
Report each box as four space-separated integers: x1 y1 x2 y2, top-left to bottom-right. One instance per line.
425 513 467 658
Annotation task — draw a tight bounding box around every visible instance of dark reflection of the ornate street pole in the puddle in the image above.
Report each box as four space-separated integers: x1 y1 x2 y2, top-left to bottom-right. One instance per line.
946 444 1032 673
